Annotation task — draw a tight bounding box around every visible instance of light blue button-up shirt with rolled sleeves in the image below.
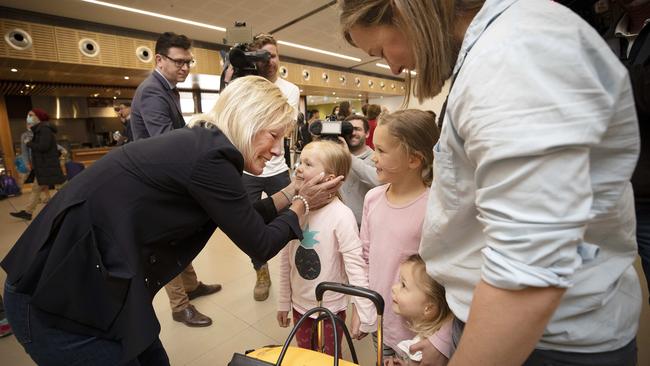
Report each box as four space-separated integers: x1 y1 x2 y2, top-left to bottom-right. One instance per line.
420 0 641 352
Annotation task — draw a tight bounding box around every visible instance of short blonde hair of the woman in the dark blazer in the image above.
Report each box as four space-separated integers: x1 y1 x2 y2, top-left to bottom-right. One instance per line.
188 76 296 161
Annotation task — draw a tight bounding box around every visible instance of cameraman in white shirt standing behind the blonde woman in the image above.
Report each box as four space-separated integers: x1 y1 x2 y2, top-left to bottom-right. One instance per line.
242 33 300 301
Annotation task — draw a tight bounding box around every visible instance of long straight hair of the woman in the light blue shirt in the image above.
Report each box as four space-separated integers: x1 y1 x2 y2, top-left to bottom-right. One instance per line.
339 0 485 104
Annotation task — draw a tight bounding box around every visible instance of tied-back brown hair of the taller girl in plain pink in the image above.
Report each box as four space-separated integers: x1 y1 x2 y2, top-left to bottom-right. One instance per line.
377 109 440 186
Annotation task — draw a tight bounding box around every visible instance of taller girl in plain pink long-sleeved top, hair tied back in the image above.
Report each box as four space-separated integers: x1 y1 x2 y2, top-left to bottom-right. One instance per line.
353 109 449 359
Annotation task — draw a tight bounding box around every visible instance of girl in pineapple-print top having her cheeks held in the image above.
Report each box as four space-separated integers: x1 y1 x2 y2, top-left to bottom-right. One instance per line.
277 141 377 357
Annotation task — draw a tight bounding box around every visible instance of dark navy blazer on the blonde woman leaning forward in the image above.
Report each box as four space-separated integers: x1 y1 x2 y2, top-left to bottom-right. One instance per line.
1 128 302 360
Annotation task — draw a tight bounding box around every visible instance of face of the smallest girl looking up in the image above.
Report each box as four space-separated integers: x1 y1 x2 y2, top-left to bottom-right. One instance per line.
392 263 433 320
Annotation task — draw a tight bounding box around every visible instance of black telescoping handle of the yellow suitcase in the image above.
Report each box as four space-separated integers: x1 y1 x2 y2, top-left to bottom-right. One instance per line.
316 282 384 366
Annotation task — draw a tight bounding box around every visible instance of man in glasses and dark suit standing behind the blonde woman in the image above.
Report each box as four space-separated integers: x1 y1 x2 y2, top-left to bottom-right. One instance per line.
131 32 221 327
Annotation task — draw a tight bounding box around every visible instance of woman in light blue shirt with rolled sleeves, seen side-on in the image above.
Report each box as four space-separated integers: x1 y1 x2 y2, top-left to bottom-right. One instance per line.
339 0 642 366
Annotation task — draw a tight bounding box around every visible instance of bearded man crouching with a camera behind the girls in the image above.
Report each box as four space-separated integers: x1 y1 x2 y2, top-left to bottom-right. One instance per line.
339 114 380 226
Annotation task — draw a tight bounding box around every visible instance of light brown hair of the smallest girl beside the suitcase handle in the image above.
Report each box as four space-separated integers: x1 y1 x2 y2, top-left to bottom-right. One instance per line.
403 254 452 338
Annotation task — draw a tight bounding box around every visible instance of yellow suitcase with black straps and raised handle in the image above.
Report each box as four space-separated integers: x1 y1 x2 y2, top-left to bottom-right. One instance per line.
228 282 384 366
